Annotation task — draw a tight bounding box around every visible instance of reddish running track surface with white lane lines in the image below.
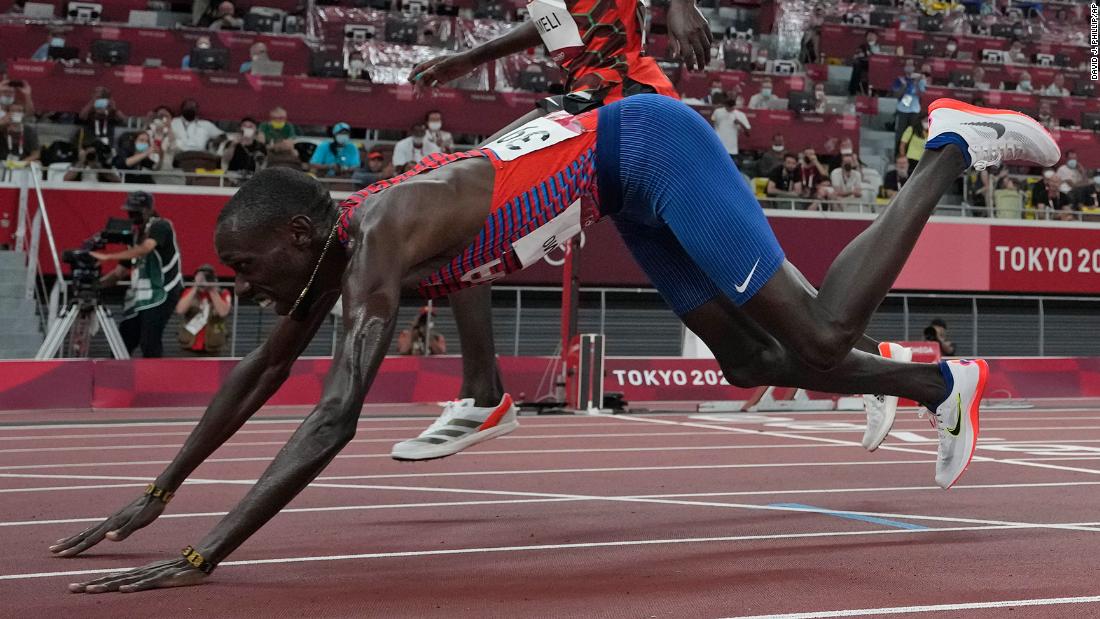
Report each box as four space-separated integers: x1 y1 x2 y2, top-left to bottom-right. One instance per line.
0 407 1100 618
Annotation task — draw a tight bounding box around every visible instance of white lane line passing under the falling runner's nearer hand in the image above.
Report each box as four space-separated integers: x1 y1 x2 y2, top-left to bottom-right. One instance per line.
0 526 1073 581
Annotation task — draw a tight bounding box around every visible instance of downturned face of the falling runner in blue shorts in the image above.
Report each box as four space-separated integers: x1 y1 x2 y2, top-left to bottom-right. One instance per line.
215 222 318 316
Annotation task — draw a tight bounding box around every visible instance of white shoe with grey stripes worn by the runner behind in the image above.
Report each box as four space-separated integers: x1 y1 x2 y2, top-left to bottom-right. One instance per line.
389 394 519 461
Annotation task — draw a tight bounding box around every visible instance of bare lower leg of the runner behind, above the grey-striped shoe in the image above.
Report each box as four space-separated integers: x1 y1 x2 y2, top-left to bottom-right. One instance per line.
448 286 504 407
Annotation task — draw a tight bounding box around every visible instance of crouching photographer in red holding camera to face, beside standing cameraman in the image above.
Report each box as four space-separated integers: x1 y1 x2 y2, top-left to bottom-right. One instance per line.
175 264 233 355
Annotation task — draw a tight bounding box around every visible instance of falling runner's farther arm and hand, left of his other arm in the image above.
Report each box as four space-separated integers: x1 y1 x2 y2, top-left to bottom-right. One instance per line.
50 295 337 556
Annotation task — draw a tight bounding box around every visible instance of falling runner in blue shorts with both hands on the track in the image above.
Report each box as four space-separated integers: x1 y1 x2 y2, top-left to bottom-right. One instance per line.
58 95 1060 593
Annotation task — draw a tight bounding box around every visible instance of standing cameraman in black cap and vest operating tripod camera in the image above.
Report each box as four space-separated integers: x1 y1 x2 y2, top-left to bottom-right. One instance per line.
91 191 184 358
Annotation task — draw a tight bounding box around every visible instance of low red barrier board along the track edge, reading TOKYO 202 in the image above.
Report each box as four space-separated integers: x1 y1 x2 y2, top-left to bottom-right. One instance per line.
0 356 1100 410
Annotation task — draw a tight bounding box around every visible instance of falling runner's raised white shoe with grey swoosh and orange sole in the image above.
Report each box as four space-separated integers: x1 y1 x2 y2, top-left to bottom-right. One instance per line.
927 99 1062 170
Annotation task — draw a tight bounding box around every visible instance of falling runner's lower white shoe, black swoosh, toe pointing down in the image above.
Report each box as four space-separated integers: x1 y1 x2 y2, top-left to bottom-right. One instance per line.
933 358 989 490
